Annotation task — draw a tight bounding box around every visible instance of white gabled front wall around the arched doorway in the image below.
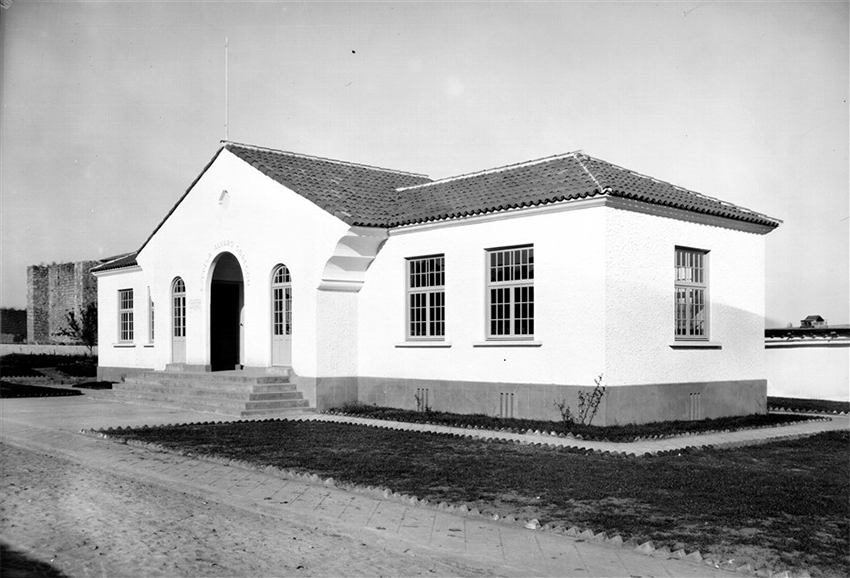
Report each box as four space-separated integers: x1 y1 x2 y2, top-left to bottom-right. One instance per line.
99 150 349 376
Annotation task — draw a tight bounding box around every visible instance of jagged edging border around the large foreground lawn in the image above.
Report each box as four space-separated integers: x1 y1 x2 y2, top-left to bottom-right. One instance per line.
79 416 829 578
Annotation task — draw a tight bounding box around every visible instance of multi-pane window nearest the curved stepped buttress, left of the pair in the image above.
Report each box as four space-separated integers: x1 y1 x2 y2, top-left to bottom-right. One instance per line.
407 255 446 339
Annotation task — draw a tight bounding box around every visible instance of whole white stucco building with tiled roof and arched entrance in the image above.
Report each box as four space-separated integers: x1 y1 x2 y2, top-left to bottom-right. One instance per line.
95 142 780 425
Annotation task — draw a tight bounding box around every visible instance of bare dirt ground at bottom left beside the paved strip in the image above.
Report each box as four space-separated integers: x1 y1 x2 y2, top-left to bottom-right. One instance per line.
0 443 500 577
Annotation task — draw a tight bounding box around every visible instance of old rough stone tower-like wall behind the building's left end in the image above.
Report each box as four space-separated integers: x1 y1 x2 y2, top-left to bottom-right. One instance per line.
27 261 99 344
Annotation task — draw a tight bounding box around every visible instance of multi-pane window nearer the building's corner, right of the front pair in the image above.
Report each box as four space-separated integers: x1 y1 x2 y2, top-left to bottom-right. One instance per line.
487 245 534 339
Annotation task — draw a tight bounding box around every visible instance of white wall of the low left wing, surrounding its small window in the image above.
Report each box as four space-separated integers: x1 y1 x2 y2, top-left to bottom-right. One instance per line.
97 267 156 369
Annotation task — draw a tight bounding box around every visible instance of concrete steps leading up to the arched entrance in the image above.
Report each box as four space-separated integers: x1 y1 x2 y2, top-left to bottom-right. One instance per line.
112 370 313 417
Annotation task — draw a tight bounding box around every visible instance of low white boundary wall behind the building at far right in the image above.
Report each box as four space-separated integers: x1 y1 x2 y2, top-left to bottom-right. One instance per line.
765 339 850 401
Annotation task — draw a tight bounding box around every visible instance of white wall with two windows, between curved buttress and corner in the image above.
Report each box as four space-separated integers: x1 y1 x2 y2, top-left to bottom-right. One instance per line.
358 203 605 384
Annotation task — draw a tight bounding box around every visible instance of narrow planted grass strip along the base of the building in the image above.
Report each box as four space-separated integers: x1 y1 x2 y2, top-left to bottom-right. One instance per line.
331 403 809 442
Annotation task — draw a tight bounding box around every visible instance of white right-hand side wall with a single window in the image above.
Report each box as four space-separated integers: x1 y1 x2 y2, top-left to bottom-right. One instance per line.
605 208 767 385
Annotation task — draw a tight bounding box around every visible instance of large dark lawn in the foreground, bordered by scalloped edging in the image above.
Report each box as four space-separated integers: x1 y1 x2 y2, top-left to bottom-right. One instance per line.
106 421 850 576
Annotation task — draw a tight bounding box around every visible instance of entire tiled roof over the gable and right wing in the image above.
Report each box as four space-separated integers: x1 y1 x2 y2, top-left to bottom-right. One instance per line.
224 142 781 227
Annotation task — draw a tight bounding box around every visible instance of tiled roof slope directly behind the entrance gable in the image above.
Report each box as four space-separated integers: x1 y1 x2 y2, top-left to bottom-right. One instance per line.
224 142 431 227
